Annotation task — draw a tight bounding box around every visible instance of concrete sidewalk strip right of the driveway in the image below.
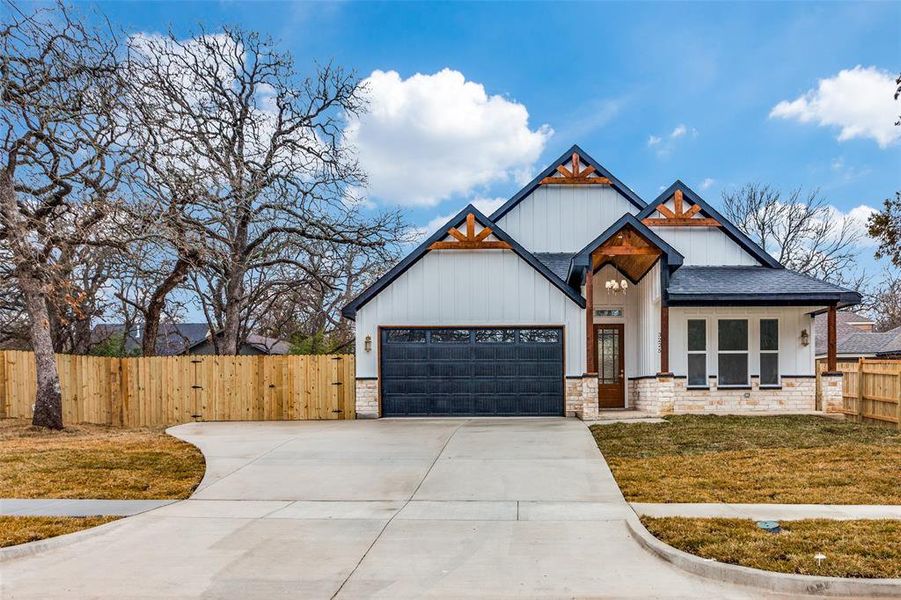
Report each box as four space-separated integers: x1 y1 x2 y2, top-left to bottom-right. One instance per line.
632 502 901 521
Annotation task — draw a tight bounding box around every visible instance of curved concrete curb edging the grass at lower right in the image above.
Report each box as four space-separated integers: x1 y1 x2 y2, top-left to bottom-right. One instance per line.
626 513 901 598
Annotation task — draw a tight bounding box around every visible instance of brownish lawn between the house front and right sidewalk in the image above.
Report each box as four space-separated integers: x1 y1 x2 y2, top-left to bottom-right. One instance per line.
591 415 901 504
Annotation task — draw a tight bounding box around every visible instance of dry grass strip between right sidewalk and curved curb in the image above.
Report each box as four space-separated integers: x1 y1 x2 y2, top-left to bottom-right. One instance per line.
641 517 901 578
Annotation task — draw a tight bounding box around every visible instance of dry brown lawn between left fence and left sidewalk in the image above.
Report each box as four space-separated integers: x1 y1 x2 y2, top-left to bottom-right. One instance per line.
0 419 204 500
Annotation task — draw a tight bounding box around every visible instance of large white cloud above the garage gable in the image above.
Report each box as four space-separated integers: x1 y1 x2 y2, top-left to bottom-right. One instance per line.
346 69 553 206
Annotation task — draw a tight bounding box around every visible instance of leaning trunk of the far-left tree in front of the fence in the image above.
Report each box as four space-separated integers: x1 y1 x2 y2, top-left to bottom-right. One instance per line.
0 171 63 429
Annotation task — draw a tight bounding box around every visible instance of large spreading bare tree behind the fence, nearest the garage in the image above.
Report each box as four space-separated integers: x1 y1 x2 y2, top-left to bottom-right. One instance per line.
131 28 404 354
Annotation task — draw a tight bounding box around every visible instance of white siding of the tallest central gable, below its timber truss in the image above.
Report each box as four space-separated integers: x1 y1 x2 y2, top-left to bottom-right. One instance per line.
497 185 638 253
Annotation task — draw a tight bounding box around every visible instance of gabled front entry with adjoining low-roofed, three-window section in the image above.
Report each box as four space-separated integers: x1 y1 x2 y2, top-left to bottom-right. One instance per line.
566 216 853 420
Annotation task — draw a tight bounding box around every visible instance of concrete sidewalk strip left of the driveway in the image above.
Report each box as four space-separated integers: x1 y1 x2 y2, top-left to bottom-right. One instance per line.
0 498 178 517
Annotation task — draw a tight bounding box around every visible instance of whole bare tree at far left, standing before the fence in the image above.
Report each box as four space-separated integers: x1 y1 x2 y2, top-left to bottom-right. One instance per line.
0 2 123 429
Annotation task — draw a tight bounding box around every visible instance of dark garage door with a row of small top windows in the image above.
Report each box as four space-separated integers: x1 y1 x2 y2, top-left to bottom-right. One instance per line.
381 328 563 417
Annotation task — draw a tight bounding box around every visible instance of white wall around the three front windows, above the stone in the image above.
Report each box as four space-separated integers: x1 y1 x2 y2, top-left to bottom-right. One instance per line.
669 306 816 377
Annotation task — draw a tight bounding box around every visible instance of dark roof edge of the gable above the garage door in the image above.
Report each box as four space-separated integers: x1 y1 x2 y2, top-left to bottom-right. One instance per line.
341 204 585 319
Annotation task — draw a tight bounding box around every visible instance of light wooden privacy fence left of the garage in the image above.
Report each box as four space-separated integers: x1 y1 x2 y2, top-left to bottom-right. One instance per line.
0 351 355 427
